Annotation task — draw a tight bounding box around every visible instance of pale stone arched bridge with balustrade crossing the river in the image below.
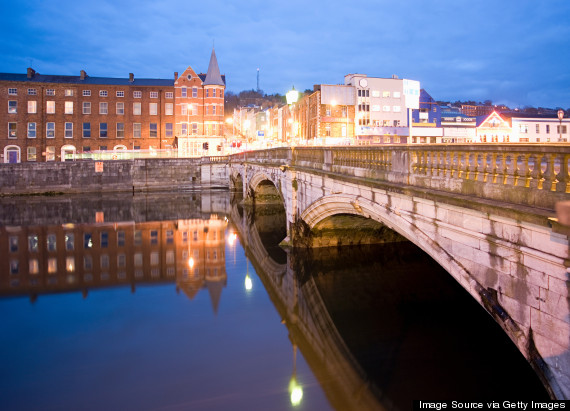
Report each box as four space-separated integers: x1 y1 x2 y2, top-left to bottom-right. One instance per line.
229 145 570 399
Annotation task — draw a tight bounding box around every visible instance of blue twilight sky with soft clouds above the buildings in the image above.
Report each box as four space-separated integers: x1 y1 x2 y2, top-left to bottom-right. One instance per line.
0 0 570 108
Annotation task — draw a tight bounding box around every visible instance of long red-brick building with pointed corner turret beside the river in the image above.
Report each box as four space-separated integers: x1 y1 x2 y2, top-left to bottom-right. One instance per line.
0 49 225 163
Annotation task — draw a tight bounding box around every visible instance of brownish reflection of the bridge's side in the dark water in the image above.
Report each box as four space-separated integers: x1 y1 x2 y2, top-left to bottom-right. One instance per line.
230 206 390 410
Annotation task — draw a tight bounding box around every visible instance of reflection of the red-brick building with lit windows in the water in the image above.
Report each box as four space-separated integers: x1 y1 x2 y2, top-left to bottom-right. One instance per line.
0 215 227 309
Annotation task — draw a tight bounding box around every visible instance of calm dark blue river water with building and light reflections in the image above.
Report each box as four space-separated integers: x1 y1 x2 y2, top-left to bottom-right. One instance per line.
0 192 543 410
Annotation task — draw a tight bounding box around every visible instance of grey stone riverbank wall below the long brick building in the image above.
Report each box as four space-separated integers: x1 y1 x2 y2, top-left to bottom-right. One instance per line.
0 157 229 195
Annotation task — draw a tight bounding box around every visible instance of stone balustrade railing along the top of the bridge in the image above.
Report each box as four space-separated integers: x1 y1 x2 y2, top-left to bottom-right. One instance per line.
236 144 570 210
